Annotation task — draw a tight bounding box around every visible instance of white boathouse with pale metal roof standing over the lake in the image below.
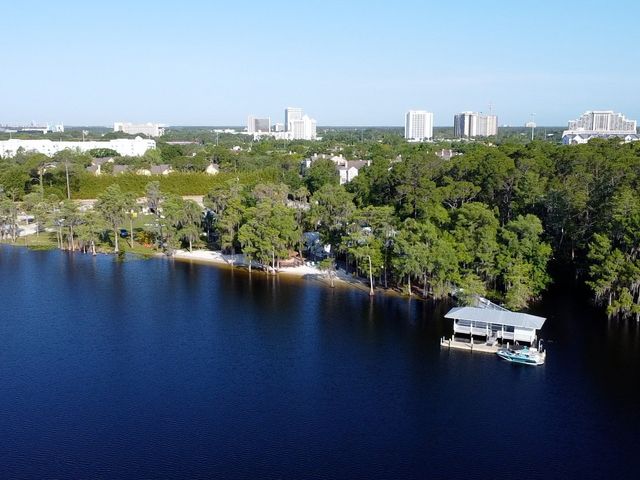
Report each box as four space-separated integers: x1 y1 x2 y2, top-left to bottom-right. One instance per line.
444 307 546 344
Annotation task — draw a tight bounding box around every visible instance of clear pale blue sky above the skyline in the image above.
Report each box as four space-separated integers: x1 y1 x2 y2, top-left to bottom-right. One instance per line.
0 0 640 125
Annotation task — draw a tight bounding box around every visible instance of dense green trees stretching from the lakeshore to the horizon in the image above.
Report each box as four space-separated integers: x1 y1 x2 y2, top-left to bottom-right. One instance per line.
0 129 640 319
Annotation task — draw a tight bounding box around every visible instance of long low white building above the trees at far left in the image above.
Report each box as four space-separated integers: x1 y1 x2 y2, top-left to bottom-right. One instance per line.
0 137 156 157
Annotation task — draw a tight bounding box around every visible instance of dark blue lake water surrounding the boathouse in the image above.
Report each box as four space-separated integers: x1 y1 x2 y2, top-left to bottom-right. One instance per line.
0 246 640 479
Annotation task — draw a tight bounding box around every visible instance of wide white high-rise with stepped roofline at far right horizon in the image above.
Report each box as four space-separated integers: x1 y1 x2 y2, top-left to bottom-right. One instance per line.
562 110 640 144
